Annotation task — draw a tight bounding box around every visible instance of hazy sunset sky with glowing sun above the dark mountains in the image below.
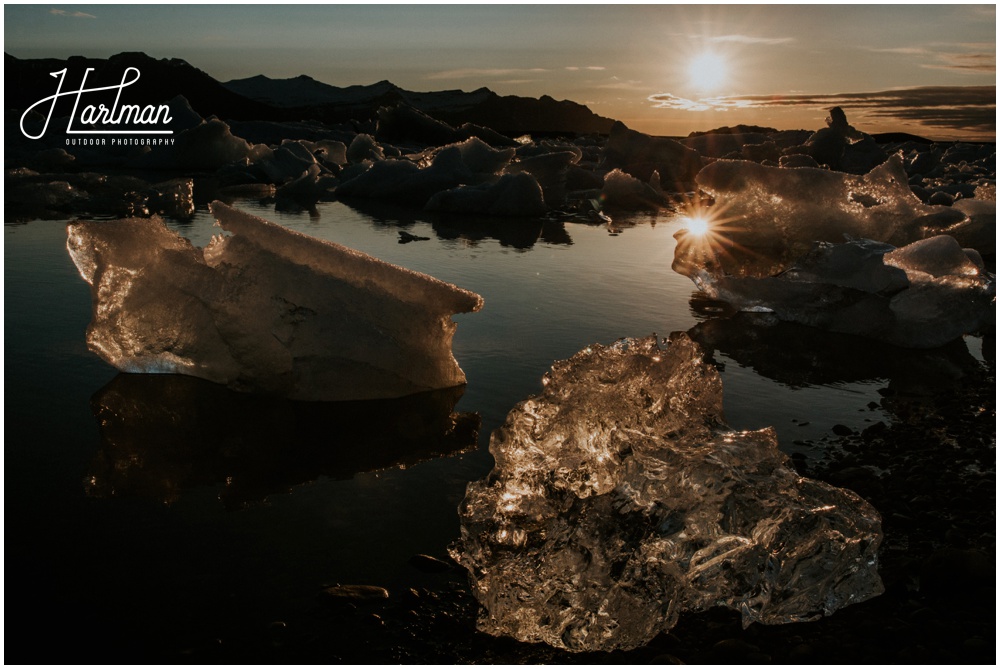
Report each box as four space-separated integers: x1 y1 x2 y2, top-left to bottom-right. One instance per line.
4 4 996 141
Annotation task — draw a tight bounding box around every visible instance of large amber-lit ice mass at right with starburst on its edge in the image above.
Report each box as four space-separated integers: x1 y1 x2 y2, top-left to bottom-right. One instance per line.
673 154 996 348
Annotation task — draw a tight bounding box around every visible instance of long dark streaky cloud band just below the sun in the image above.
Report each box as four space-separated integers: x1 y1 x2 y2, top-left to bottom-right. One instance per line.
648 86 996 135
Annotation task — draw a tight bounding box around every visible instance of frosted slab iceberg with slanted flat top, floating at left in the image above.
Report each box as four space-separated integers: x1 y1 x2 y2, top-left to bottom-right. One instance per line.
67 202 482 400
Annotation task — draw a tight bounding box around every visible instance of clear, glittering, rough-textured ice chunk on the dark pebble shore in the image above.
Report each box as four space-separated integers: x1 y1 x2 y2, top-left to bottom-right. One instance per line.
452 334 883 651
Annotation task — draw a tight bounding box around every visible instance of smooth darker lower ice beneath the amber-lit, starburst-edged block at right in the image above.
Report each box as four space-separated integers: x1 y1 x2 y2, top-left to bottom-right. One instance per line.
674 235 996 348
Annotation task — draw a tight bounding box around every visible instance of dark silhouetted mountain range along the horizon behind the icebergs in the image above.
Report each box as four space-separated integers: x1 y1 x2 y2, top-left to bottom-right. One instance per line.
4 52 614 137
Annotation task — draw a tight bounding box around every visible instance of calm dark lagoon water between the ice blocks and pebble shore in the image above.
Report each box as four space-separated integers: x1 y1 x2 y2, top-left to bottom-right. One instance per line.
4 197 978 662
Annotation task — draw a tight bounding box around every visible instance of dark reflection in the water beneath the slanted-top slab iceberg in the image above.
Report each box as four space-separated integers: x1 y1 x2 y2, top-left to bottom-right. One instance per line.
85 374 480 508
